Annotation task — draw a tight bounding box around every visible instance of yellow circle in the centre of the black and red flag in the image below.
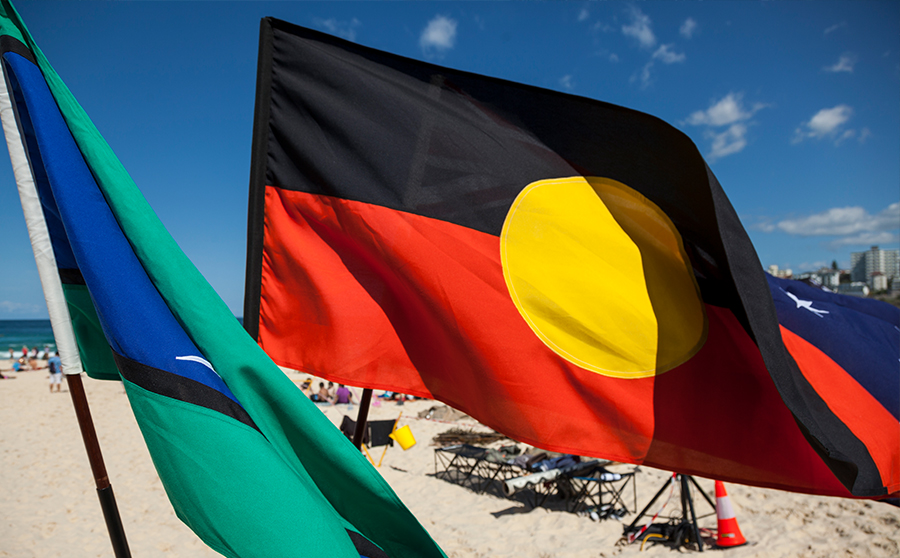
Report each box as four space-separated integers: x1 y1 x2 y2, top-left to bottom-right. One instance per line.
500 176 707 378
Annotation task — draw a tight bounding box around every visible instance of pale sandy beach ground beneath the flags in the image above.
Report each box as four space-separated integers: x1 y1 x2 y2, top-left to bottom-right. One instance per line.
0 360 900 558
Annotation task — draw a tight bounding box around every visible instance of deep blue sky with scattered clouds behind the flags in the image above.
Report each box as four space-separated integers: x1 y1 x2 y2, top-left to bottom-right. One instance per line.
0 0 900 319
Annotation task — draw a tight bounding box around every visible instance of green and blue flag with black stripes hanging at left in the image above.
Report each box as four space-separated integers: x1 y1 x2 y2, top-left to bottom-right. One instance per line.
0 0 443 558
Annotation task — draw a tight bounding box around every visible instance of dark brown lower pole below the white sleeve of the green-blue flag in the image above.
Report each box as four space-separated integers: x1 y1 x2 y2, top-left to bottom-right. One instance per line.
66 374 131 558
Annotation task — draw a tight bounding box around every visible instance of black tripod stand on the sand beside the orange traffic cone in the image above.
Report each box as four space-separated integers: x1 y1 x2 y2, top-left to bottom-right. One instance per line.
624 473 716 552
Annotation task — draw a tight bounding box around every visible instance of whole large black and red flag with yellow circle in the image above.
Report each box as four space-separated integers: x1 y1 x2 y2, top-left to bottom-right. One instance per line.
244 19 900 496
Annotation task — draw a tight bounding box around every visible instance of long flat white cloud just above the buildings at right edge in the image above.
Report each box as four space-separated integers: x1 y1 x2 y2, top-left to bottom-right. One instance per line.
776 202 900 238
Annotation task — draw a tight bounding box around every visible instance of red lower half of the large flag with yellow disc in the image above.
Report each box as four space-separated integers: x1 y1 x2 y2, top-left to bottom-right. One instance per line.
259 187 849 496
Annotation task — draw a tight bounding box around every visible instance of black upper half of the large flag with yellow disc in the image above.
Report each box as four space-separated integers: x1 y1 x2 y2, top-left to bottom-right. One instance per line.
251 19 755 306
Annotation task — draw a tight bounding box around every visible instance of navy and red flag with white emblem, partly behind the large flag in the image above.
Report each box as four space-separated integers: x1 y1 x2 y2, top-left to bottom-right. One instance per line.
768 276 900 498
